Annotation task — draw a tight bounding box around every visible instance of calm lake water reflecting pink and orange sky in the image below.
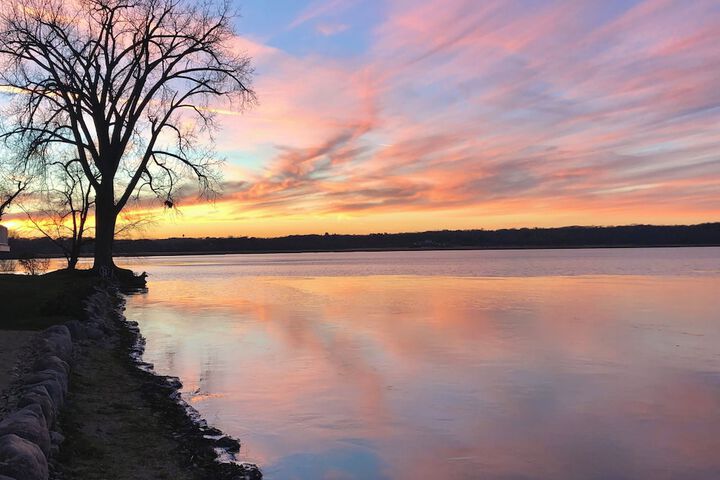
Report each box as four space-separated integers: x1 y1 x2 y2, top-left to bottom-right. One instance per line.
122 248 720 480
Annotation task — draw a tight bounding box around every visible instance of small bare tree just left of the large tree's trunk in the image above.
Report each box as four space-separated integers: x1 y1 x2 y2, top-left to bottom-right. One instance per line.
22 161 95 270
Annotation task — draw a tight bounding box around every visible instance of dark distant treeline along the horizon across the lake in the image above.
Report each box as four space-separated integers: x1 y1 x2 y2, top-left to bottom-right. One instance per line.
2 223 720 257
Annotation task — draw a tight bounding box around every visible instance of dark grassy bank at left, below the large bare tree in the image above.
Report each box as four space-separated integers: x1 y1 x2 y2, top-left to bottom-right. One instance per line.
0 270 97 330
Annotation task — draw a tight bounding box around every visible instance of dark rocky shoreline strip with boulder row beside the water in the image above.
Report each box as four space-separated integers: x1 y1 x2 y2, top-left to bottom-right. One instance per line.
0 287 262 480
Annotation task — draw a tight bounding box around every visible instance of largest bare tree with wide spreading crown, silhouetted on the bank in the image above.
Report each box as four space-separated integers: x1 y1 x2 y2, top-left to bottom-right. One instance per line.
0 0 255 270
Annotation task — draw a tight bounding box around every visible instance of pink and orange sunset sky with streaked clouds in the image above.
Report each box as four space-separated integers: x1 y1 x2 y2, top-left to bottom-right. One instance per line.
8 0 720 237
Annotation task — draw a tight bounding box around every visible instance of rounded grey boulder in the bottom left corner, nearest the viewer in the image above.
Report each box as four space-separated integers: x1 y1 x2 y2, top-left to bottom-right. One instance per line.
0 434 48 480
